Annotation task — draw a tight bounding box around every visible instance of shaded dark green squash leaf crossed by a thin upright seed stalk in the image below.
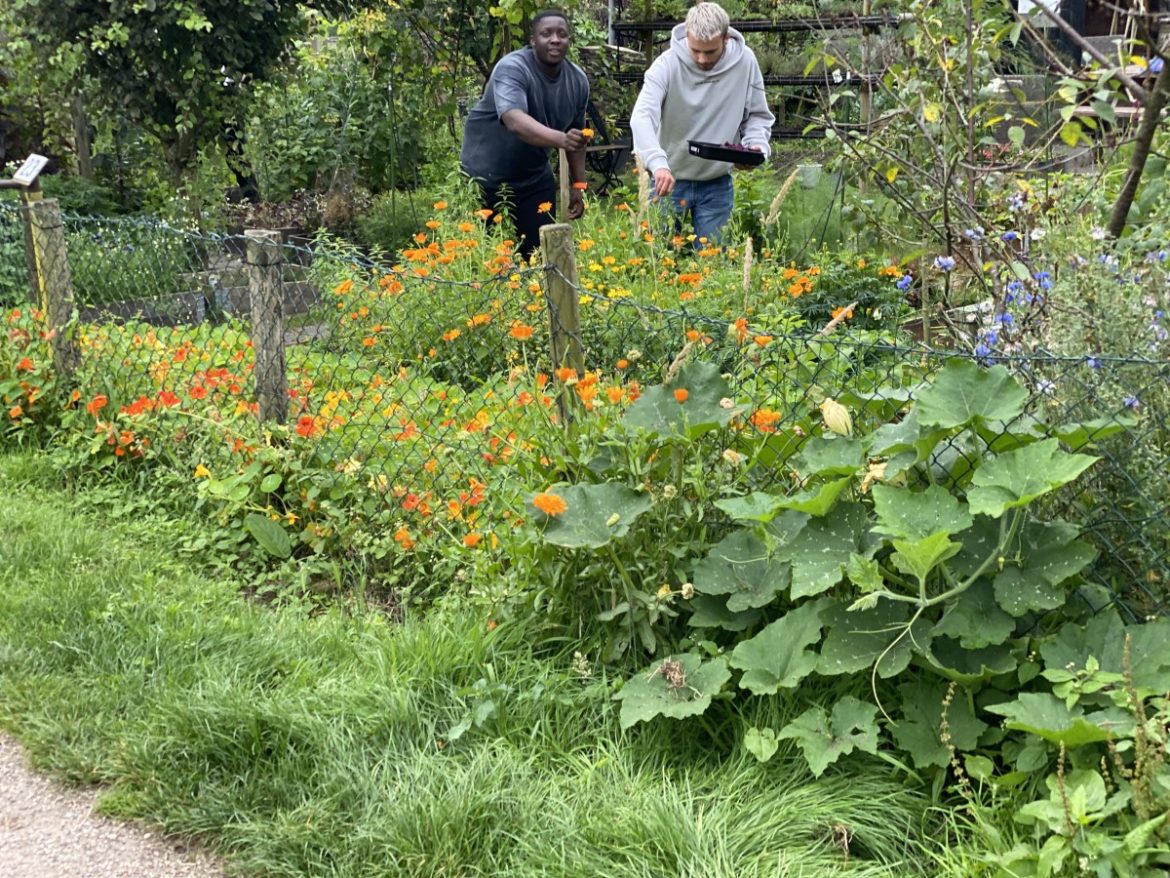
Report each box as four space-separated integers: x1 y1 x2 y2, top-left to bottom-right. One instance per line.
890 680 987 768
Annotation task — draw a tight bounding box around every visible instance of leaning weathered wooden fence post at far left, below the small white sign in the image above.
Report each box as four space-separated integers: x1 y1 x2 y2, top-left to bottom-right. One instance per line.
27 198 81 378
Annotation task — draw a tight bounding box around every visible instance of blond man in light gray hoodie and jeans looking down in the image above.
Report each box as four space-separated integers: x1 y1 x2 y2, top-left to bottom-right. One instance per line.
629 2 776 242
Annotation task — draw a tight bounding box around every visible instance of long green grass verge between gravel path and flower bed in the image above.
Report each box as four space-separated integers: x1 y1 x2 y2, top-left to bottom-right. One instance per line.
0 455 940 878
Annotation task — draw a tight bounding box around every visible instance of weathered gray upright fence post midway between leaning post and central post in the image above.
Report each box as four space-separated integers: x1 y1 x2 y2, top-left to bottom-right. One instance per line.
243 229 289 424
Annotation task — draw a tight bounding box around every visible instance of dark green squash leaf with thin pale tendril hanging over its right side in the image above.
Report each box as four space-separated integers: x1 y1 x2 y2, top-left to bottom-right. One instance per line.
817 601 930 679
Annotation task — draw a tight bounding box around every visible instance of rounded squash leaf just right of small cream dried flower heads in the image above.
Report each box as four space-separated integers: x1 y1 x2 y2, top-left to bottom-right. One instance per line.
694 529 791 612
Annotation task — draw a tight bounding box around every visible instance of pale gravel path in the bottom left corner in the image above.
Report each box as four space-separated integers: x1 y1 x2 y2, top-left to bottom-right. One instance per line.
0 735 223 878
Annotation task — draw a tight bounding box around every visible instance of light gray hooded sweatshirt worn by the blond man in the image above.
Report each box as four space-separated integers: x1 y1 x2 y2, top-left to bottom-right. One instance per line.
629 25 776 180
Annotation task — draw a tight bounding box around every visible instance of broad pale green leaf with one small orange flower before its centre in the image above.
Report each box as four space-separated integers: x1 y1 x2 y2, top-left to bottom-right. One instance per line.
622 363 741 438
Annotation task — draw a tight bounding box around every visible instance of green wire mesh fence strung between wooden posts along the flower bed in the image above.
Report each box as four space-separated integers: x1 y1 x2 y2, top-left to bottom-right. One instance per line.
0 203 1170 615
